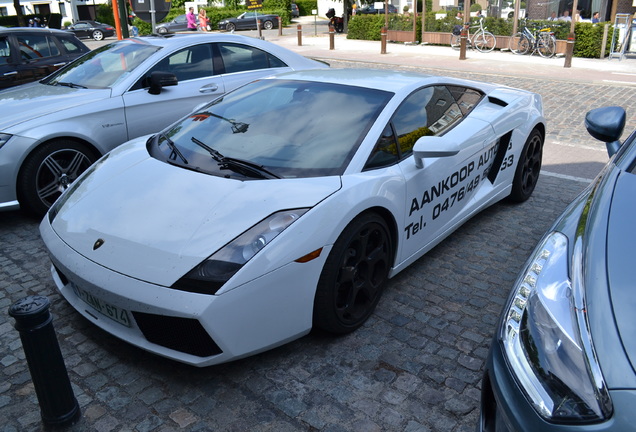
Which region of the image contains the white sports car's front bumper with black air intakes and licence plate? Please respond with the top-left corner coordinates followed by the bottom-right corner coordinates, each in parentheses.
top-left (40, 218), bottom-right (329, 366)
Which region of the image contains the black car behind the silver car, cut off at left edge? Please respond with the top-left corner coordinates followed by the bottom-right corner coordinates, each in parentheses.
top-left (0, 27), bottom-right (90, 89)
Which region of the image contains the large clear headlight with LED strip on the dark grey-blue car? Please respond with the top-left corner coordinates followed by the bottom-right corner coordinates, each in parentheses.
top-left (500, 232), bottom-right (611, 423)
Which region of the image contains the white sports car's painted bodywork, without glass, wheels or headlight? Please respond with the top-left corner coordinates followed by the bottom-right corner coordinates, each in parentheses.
top-left (41, 70), bottom-right (544, 366)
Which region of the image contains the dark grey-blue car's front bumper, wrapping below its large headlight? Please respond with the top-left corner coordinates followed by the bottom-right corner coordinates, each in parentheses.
top-left (477, 338), bottom-right (636, 432)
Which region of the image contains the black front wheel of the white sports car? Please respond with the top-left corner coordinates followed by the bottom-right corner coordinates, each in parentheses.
top-left (313, 213), bottom-right (393, 334)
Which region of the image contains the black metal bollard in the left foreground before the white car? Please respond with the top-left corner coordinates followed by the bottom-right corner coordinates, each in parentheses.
top-left (9, 296), bottom-right (81, 426)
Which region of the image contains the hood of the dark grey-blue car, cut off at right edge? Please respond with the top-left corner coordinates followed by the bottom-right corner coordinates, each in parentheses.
top-left (607, 172), bottom-right (636, 370)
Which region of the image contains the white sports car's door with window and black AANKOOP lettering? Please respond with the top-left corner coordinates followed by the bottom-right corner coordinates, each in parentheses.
top-left (392, 85), bottom-right (494, 257)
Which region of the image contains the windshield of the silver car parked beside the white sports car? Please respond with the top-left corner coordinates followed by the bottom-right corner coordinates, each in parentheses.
top-left (42, 40), bottom-right (160, 89)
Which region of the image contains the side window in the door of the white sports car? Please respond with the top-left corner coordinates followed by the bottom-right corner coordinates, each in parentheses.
top-left (393, 86), bottom-right (462, 157)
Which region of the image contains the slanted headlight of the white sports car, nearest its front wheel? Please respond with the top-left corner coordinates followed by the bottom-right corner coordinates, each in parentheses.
top-left (172, 208), bottom-right (309, 294)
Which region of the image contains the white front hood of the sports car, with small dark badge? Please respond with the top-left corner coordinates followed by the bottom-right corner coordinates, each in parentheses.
top-left (52, 140), bottom-right (341, 285)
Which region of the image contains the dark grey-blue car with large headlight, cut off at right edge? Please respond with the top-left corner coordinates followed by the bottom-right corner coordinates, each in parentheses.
top-left (477, 107), bottom-right (636, 432)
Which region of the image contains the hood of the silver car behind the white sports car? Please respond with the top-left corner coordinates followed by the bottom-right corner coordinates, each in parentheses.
top-left (0, 82), bottom-right (110, 133)
